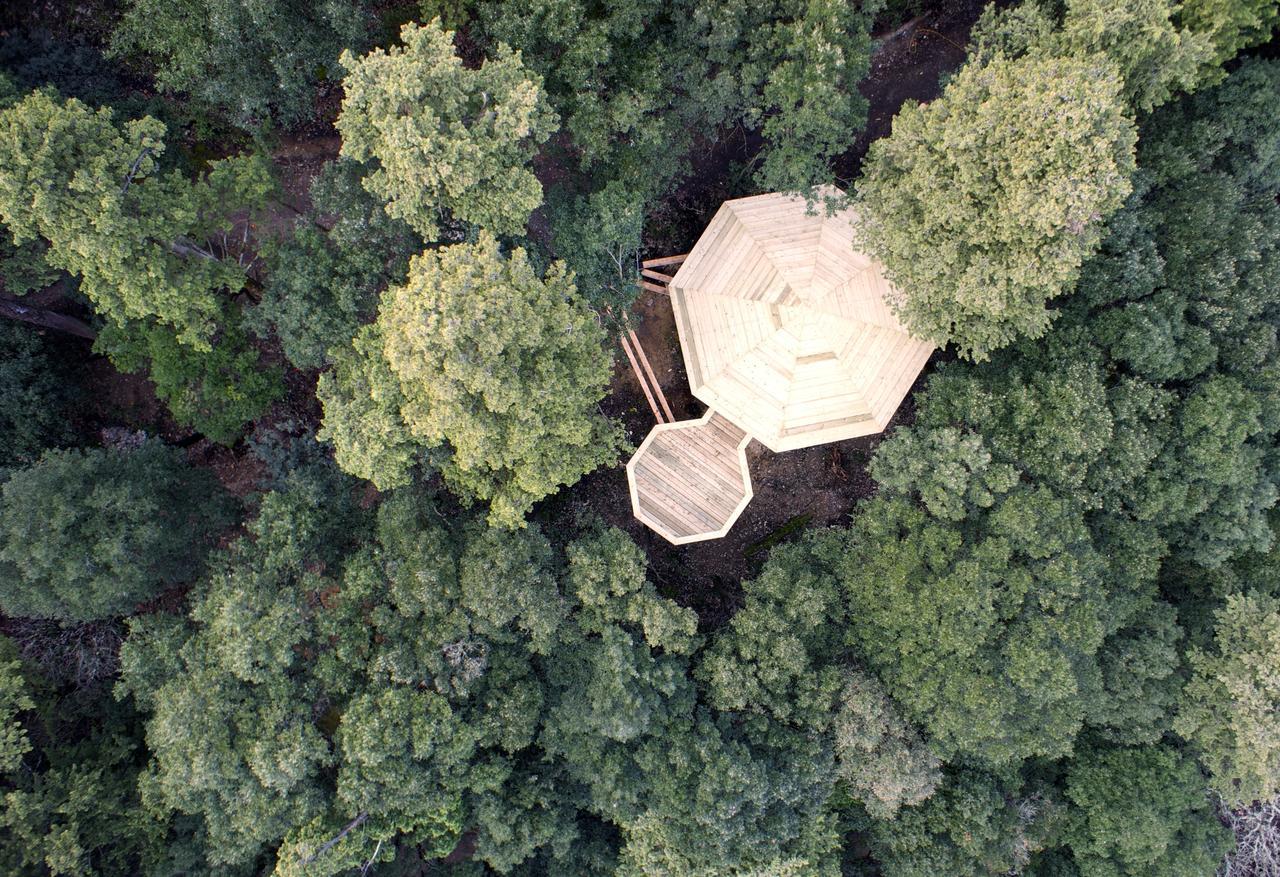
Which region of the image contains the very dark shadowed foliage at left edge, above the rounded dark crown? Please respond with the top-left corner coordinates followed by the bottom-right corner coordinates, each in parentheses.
top-left (0, 323), bottom-right (76, 466)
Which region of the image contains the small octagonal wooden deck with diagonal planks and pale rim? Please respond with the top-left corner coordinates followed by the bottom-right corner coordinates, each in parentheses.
top-left (627, 411), bottom-right (751, 545)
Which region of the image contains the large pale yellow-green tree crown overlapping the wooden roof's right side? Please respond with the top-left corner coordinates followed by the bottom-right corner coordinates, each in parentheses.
top-left (858, 54), bottom-right (1135, 361)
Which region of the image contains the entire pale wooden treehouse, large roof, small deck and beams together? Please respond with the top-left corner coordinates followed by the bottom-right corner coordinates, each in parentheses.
top-left (623, 188), bottom-right (933, 544)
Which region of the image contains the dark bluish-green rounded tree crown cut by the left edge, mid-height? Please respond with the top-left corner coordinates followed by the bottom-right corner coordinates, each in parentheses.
top-left (0, 440), bottom-right (235, 621)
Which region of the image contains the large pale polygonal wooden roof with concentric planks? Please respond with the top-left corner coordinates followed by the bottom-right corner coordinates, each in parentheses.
top-left (668, 187), bottom-right (933, 451)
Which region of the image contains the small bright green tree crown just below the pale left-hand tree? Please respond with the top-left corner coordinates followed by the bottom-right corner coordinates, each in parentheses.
top-left (95, 311), bottom-right (284, 444)
